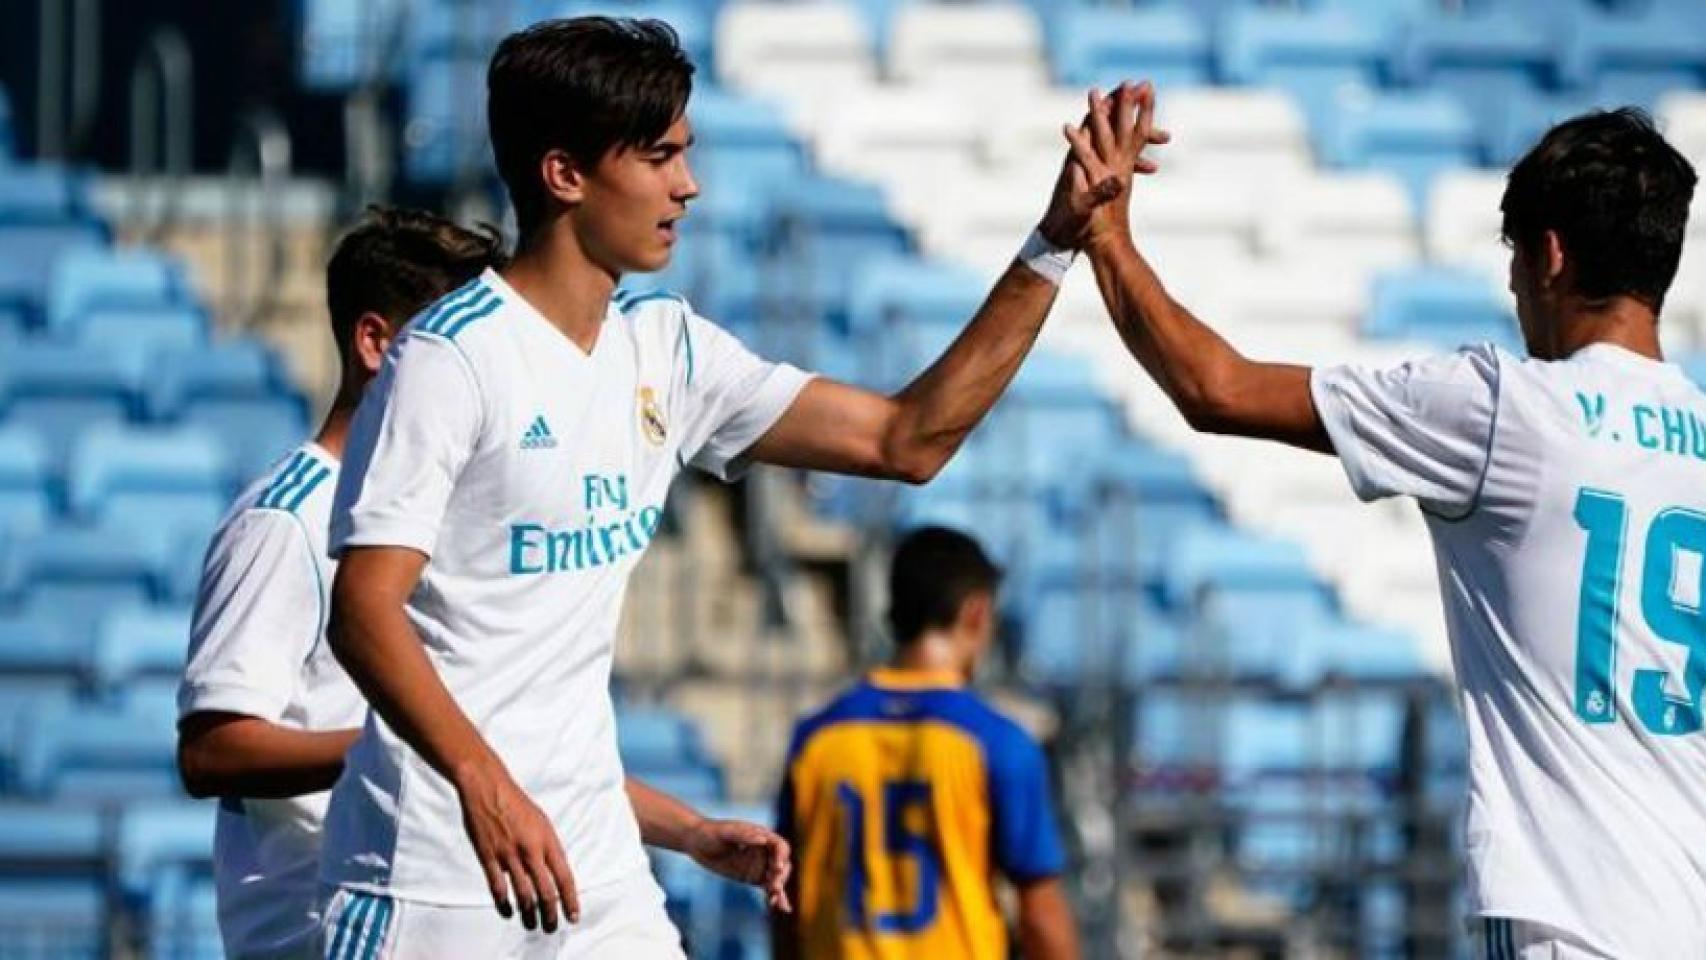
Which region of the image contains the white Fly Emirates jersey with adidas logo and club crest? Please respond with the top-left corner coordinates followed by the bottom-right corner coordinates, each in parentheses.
top-left (322, 271), bottom-right (807, 905)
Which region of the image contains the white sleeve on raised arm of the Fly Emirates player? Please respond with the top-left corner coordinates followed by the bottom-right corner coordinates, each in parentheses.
top-left (677, 310), bottom-right (810, 481)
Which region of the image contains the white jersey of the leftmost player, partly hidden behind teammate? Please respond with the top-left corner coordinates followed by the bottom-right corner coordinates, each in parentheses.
top-left (177, 443), bottom-right (367, 957)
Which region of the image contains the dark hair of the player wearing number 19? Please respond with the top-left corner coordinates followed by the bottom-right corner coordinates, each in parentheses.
top-left (1500, 107), bottom-right (1696, 310)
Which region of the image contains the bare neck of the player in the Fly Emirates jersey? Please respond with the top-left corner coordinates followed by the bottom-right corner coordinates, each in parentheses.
top-left (503, 217), bottom-right (618, 353)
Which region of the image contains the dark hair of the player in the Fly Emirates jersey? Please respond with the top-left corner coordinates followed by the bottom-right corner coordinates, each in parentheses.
top-left (486, 17), bottom-right (693, 237)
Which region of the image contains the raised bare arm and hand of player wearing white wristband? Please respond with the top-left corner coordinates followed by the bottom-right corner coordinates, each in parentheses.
top-left (749, 91), bottom-right (1167, 483)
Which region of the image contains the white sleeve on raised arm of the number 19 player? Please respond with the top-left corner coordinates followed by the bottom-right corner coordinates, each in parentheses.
top-left (1310, 344), bottom-right (1500, 518)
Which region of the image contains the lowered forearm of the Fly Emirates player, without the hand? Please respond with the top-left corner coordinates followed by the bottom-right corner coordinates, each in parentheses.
top-left (328, 593), bottom-right (502, 783)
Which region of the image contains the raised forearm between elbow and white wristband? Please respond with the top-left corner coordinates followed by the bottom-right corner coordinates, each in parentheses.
top-left (884, 261), bottom-right (1059, 479)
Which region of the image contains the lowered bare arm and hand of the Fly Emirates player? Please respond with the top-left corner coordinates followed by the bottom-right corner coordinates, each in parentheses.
top-left (326, 547), bottom-right (580, 931)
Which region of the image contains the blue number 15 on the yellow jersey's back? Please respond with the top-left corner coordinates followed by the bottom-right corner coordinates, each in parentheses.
top-left (836, 779), bottom-right (942, 934)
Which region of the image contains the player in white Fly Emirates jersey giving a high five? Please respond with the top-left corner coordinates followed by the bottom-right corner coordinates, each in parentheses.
top-left (322, 17), bottom-right (1160, 958)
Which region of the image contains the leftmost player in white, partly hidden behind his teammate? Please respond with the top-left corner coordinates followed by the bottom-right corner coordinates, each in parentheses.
top-left (177, 208), bottom-right (500, 958)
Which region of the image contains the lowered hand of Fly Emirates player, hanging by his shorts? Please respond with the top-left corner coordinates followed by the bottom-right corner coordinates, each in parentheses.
top-left (457, 760), bottom-right (580, 933)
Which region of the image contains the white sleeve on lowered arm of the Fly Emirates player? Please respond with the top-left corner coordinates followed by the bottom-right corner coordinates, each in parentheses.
top-left (331, 334), bottom-right (483, 556)
